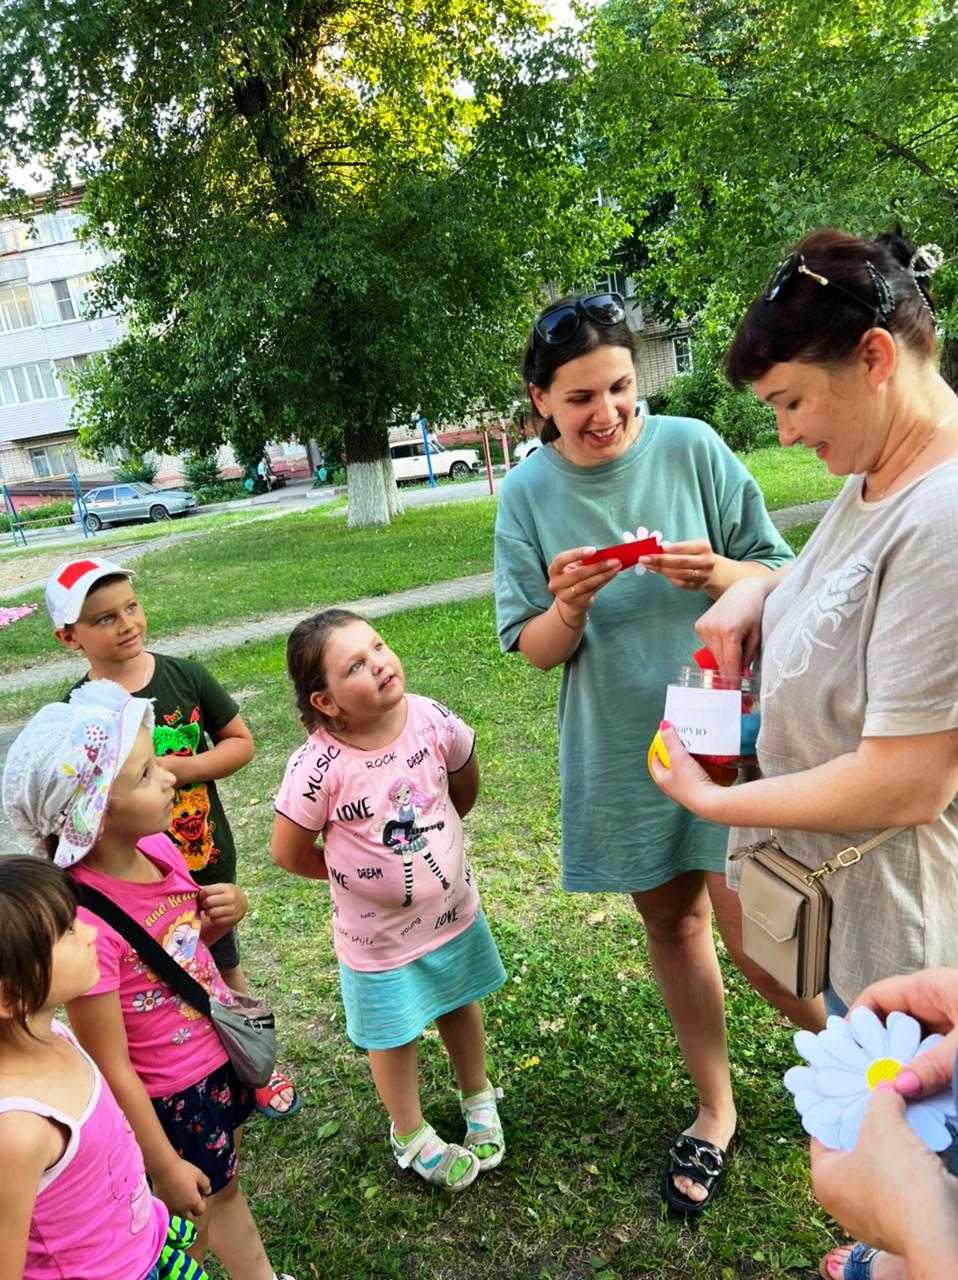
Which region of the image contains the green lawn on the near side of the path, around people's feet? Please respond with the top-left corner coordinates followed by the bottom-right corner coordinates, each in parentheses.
top-left (178, 602), bottom-right (830, 1280)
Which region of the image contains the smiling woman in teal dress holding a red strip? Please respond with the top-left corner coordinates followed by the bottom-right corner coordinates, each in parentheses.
top-left (496, 294), bottom-right (792, 1216)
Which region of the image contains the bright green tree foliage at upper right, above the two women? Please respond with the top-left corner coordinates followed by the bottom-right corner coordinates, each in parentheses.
top-left (588, 0), bottom-right (958, 355)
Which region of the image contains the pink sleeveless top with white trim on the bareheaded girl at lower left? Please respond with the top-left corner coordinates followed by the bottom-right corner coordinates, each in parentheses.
top-left (0, 1021), bottom-right (169, 1280)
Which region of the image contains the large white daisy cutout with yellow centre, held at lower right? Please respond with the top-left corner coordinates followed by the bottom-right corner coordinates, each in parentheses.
top-left (785, 1009), bottom-right (955, 1151)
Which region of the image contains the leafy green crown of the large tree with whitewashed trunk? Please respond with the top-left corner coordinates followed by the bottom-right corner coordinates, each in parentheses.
top-left (0, 0), bottom-right (625, 512)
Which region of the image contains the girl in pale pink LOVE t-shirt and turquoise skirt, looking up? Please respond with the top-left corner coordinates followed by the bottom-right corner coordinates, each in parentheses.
top-left (273, 609), bottom-right (506, 1190)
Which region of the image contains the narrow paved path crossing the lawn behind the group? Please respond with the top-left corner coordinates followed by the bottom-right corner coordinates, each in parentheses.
top-left (3, 502), bottom-right (829, 692)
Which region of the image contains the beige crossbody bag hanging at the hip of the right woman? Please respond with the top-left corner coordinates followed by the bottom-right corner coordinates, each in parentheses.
top-left (729, 827), bottom-right (905, 997)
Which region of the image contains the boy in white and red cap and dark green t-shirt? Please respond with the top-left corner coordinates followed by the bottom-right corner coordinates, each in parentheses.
top-left (45, 556), bottom-right (298, 1116)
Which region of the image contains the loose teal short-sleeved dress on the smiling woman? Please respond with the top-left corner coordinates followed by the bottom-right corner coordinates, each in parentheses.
top-left (496, 416), bottom-right (792, 893)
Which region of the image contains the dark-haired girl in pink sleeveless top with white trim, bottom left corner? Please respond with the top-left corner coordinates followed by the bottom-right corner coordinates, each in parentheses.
top-left (0, 858), bottom-right (199, 1280)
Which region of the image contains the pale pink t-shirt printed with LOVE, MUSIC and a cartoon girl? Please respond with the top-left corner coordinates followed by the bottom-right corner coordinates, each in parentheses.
top-left (275, 694), bottom-right (479, 973)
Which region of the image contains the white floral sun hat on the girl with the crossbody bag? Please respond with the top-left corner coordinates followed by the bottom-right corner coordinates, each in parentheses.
top-left (3, 680), bottom-right (154, 867)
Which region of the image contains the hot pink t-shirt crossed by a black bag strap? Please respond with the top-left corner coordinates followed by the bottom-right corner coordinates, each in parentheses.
top-left (69, 835), bottom-right (232, 1098)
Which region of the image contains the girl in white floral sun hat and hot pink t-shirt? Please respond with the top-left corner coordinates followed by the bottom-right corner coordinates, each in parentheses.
top-left (0, 680), bottom-right (289, 1280)
